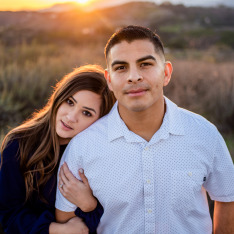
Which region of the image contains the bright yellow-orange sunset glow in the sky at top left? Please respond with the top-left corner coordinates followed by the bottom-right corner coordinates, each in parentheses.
top-left (0, 0), bottom-right (94, 11)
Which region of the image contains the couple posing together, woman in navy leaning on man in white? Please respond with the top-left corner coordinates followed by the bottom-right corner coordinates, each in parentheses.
top-left (0, 26), bottom-right (234, 234)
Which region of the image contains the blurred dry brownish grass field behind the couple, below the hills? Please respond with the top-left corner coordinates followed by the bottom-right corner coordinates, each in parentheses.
top-left (0, 43), bottom-right (234, 157)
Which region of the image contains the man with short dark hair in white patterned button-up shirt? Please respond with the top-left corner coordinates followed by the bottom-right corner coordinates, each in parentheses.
top-left (56, 26), bottom-right (234, 234)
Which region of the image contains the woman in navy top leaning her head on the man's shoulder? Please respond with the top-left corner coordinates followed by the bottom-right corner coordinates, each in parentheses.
top-left (0, 65), bottom-right (114, 233)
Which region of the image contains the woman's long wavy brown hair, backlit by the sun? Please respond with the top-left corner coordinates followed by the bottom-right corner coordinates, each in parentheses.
top-left (1, 65), bottom-right (115, 200)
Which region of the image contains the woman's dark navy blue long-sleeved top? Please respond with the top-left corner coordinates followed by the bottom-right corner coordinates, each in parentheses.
top-left (0, 140), bottom-right (103, 234)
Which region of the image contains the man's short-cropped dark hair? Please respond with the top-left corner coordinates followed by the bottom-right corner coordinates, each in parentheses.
top-left (104, 25), bottom-right (164, 59)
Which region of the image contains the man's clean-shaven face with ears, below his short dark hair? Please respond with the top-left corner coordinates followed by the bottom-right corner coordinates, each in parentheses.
top-left (105, 40), bottom-right (172, 112)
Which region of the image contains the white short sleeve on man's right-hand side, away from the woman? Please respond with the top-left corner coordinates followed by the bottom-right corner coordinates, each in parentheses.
top-left (204, 131), bottom-right (234, 202)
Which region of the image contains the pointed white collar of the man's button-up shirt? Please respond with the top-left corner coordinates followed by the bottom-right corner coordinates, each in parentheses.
top-left (108, 97), bottom-right (184, 142)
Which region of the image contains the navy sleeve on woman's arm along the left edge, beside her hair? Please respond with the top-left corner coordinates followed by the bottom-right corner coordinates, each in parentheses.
top-left (0, 140), bottom-right (55, 234)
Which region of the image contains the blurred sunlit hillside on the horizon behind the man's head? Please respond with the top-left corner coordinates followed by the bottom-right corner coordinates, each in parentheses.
top-left (0, 2), bottom-right (234, 49)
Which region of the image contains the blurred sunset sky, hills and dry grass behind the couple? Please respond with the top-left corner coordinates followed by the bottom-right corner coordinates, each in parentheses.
top-left (0, 0), bottom-right (234, 232)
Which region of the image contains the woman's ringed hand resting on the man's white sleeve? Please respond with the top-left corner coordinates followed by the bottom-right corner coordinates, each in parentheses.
top-left (58, 163), bottom-right (97, 212)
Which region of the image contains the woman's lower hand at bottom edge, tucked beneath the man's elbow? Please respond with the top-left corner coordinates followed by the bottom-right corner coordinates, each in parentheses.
top-left (49, 217), bottom-right (89, 234)
